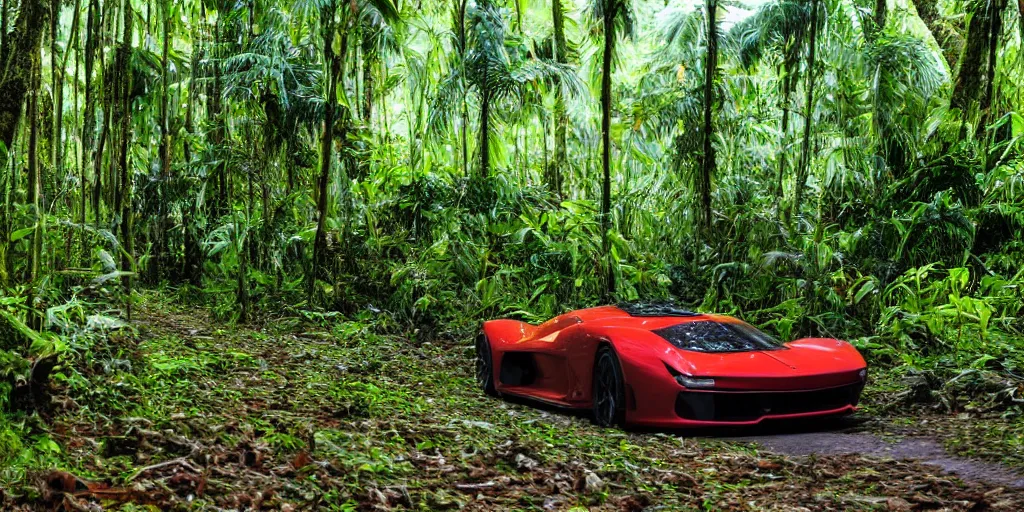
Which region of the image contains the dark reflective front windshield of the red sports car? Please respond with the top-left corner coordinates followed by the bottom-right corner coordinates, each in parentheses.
top-left (654, 321), bottom-right (784, 352)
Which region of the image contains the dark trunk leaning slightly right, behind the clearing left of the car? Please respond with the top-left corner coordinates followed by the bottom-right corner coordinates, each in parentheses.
top-left (308, 1), bottom-right (347, 302)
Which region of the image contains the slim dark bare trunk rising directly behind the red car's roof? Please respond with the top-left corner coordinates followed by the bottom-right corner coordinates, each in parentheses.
top-left (601, 12), bottom-right (615, 298)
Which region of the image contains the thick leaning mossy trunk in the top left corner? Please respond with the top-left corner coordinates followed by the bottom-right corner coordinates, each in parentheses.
top-left (0, 0), bottom-right (50, 149)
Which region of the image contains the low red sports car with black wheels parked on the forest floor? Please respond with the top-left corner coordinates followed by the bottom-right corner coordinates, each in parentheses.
top-left (476, 304), bottom-right (867, 428)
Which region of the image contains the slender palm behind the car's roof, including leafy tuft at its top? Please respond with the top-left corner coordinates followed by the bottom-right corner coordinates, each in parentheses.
top-left (590, 0), bottom-right (634, 297)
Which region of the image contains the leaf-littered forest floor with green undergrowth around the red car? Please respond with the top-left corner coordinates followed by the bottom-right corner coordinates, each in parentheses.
top-left (6, 295), bottom-right (1024, 511)
